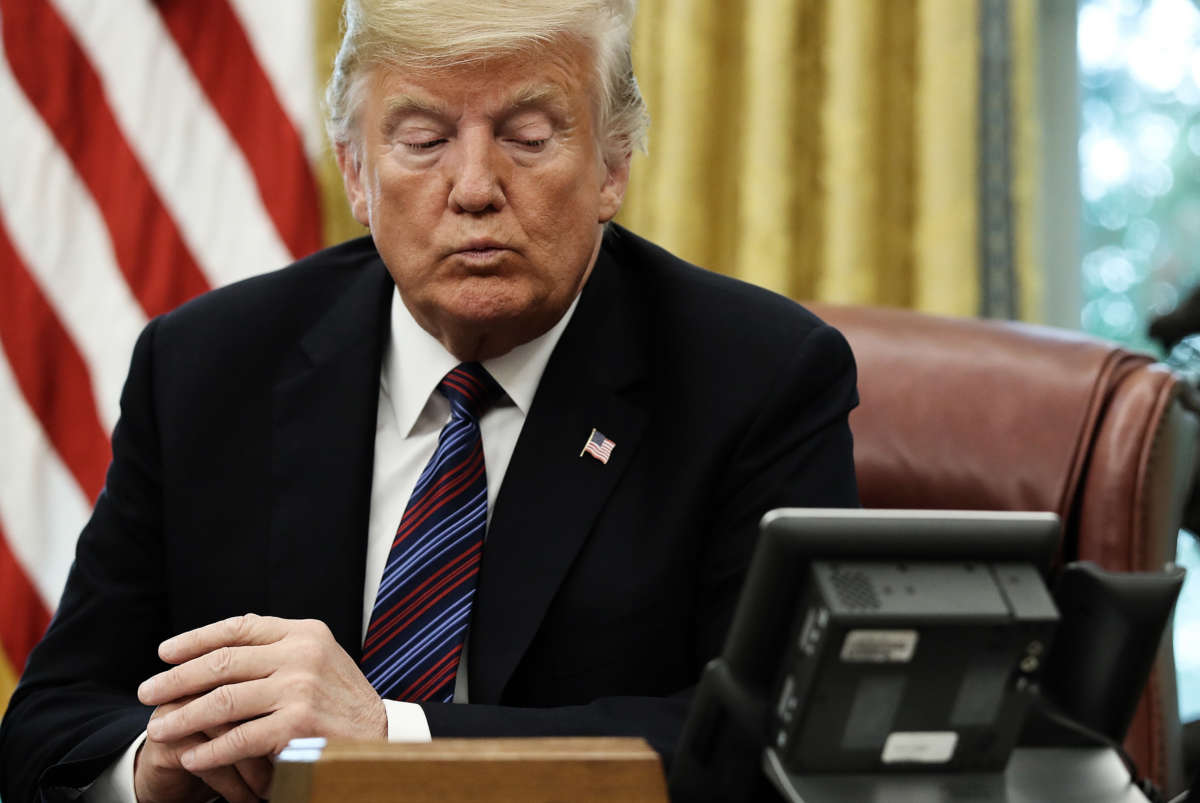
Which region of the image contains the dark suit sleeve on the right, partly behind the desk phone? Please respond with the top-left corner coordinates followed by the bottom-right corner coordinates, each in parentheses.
top-left (421, 325), bottom-right (858, 768)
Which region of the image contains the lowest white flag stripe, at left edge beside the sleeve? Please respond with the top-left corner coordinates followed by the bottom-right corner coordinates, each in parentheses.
top-left (0, 354), bottom-right (91, 611)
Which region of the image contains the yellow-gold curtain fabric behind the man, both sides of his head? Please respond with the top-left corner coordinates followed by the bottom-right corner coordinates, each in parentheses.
top-left (317, 0), bottom-right (1039, 314)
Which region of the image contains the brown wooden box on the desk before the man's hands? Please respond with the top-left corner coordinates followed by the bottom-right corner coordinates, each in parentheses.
top-left (271, 738), bottom-right (667, 803)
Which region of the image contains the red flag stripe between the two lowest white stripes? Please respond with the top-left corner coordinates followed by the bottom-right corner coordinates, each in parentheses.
top-left (0, 214), bottom-right (109, 501)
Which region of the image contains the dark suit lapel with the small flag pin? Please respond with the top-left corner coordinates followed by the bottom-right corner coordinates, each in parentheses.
top-left (468, 244), bottom-right (646, 703)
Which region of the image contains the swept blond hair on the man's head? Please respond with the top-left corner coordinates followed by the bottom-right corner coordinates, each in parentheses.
top-left (325, 0), bottom-right (649, 164)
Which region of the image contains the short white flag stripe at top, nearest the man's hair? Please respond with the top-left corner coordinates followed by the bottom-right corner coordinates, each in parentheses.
top-left (229, 0), bottom-right (325, 161)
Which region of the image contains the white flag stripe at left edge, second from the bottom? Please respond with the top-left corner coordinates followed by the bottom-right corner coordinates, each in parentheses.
top-left (0, 42), bottom-right (145, 432)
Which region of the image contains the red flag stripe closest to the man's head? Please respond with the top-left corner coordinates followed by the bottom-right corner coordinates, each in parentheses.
top-left (156, 0), bottom-right (322, 258)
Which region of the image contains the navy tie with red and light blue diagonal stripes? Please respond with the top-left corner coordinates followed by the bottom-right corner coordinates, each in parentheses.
top-left (361, 362), bottom-right (502, 702)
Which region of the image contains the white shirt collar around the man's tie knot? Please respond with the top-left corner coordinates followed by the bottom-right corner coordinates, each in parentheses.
top-left (379, 288), bottom-right (580, 438)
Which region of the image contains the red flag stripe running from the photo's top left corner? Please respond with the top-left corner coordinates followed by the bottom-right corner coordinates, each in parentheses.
top-left (0, 0), bottom-right (209, 317)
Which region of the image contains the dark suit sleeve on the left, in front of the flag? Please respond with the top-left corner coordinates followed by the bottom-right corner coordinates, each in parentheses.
top-left (0, 323), bottom-right (166, 801)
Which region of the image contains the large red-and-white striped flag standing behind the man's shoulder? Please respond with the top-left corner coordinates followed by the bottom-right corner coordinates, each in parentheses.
top-left (0, 0), bottom-right (343, 712)
